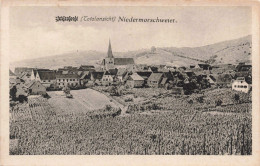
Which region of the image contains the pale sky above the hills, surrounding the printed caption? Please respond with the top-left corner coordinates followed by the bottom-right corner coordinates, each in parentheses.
top-left (9, 6), bottom-right (252, 62)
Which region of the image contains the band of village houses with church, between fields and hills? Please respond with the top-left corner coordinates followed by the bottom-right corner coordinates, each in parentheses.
top-left (9, 41), bottom-right (252, 99)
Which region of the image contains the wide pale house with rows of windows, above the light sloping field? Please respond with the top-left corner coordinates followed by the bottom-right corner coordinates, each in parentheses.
top-left (56, 74), bottom-right (80, 88)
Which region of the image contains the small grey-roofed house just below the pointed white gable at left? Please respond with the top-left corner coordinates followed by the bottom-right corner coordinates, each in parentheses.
top-left (26, 80), bottom-right (46, 95)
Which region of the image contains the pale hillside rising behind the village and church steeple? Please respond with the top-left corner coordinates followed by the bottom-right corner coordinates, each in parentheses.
top-left (10, 35), bottom-right (252, 68)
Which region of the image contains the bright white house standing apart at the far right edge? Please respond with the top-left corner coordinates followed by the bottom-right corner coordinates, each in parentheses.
top-left (232, 77), bottom-right (251, 93)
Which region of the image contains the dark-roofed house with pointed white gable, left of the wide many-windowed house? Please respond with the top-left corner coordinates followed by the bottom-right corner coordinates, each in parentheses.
top-left (34, 70), bottom-right (56, 88)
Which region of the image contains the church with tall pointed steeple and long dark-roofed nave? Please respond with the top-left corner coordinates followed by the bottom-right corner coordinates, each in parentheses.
top-left (101, 40), bottom-right (136, 71)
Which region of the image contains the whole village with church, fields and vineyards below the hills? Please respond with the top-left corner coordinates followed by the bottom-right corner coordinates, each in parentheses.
top-left (9, 41), bottom-right (252, 155)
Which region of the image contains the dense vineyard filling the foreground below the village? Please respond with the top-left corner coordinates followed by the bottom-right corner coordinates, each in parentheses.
top-left (10, 90), bottom-right (252, 155)
